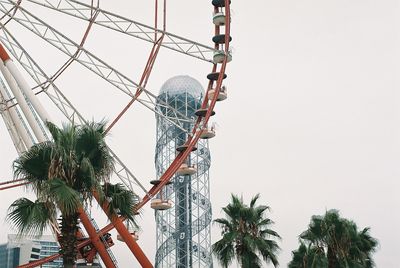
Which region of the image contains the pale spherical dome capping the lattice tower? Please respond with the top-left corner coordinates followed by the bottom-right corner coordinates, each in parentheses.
top-left (159, 75), bottom-right (204, 99)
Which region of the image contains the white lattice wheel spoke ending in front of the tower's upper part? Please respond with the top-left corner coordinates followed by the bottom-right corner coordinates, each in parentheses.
top-left (0, 0), bottom-right (194, 132)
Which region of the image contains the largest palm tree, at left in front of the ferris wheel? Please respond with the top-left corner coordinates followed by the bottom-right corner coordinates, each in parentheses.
top-left (7, 122), bottom-right (136, 267)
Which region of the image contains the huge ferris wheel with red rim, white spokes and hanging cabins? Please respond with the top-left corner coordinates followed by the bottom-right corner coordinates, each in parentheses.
top-left (0, 0), bottom-right (232, 268)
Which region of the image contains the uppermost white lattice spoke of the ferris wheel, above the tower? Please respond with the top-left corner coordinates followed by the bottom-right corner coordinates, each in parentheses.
top-left (26, 0), bottom-right (215, 62)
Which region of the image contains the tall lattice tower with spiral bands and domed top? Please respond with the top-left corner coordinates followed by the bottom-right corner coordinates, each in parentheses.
top-left (155, 76), bottom-right (212, 268)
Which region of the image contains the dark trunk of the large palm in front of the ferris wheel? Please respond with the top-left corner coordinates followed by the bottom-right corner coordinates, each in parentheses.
top-left (59, 214), bottom-right (78, 268)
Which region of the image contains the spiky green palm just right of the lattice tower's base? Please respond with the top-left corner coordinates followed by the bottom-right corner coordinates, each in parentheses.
top-left (212, 194), bottom-right (280, 268)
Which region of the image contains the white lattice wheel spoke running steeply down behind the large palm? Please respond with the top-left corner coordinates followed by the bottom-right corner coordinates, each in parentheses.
top-left (0, 24), bottom-right (147, 197)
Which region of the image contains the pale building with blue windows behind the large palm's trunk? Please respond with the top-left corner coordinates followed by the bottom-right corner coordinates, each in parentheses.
top-left (0, 234), bottom-right (62, 268)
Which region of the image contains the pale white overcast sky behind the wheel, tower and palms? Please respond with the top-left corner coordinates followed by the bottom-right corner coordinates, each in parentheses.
top-left (0, 0), bottom-right (400, 268)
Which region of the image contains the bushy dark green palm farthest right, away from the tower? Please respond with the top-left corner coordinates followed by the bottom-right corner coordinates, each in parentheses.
top-left (291, 210), bottom-right (378, 268)
